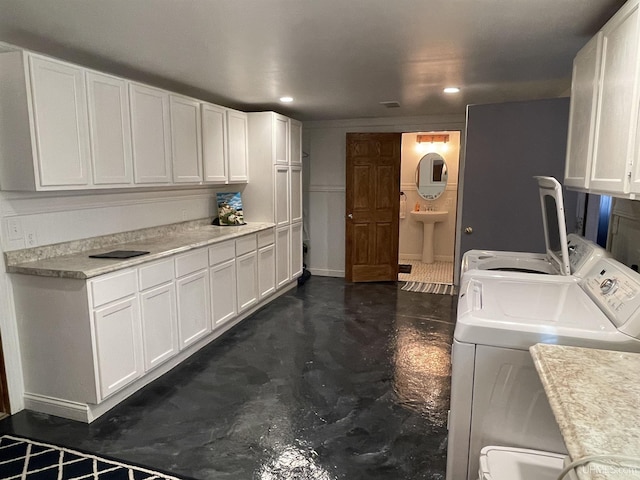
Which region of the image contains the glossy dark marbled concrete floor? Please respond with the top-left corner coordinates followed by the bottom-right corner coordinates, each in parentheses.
top-left (0, 277), bottom-right (456, 480)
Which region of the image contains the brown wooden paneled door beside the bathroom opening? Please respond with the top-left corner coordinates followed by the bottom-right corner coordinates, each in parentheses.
top-left (345, 133), bottom-right (402, 282)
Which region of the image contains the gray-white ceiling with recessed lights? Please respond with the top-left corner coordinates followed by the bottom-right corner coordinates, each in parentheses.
top-left (0, 0), bottom-right (624, 121)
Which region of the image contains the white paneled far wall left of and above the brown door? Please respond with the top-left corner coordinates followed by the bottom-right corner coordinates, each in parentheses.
top-left (303, 115), bottom-right (465, 277)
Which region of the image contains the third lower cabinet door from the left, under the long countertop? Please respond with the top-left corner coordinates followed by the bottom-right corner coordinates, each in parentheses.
top-left (176, 270), bottom-right (211, 349)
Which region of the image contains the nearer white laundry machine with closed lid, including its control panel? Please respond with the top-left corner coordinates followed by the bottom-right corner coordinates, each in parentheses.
top-left (446, 258), bottom-right (640, 480)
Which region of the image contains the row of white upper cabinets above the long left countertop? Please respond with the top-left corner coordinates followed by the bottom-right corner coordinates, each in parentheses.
top-left (0, 51), bottom-right (249, 190)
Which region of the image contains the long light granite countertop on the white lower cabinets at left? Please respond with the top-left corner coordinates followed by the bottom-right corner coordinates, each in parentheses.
top-left (5, 219), bottom-right (274, 279)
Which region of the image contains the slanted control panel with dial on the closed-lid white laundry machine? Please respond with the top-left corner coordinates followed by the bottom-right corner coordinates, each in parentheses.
top-left (580, 258), bottom-right (640, 338)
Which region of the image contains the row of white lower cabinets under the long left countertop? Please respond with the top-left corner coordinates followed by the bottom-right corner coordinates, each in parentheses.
top-left (12, 225), bottom-right (290, 422)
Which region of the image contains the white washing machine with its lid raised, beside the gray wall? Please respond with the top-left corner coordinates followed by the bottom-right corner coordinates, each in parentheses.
top-left (460, 177), bottom-right (609, 291)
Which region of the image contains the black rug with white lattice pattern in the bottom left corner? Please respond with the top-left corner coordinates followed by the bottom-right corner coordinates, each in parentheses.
top-left (0, 435), bottom-right (185, 480)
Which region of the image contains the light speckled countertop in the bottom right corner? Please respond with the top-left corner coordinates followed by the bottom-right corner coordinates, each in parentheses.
top-left (530, 344), bottom-right (640, 480)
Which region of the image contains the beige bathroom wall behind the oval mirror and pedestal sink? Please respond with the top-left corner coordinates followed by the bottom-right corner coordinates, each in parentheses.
top-left (399, 131), bottom-right (460, 262)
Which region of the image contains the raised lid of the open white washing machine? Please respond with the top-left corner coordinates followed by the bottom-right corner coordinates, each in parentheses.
top-left (534, 176), bottom-right (571, 275)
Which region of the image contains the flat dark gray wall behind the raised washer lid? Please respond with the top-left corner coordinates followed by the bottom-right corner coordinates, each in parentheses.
top-left (460, 98), bottom-right (577, 253)
